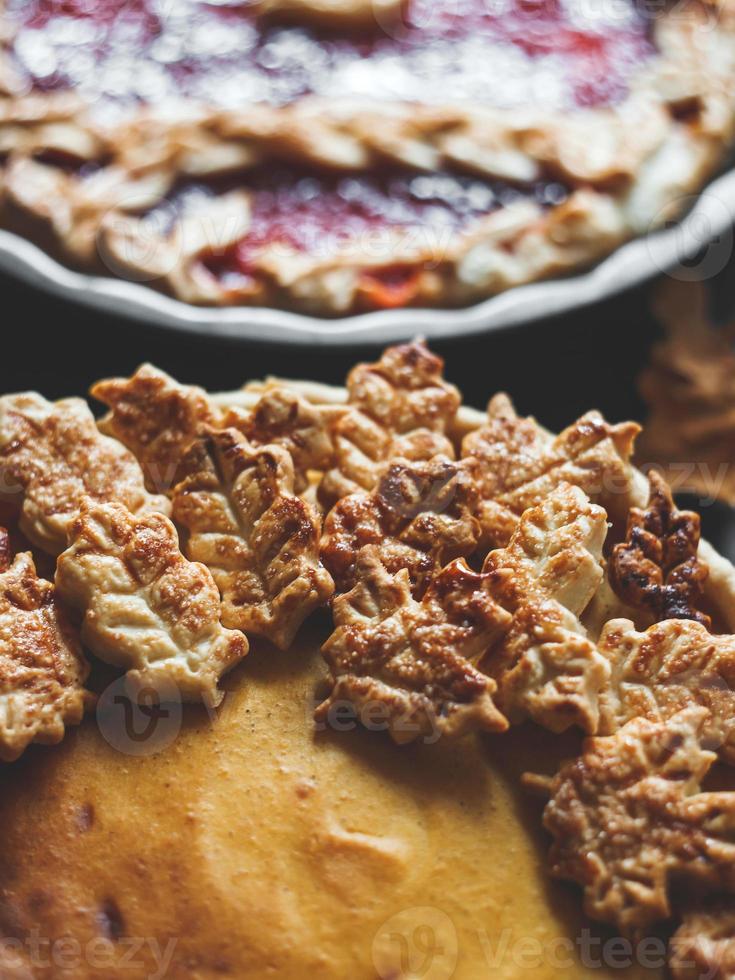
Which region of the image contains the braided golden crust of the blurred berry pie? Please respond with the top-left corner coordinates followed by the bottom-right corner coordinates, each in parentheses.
top-left (0, 0), bottom-right (735, 315)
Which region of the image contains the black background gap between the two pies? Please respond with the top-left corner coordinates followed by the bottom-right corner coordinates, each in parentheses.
top-left (0, 236), bottom-right (735, 440)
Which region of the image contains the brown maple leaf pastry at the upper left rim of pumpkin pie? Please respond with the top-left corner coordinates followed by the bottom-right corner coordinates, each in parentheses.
top-left (90, 364), bottom-right (219, 493)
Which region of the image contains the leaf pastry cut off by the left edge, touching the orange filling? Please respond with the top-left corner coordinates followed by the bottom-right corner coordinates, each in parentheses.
top-left (0, 528), bottom-right (92, 762)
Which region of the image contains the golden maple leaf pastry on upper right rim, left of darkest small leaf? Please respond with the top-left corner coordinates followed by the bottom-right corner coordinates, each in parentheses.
top-left (462, 394), bottom-right (640, 548)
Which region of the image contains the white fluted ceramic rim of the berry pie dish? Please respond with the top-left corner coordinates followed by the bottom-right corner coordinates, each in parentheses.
top-left (0, 170), bottom-right (735, 345)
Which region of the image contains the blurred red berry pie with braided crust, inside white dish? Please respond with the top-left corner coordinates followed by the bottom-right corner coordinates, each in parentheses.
top-left (0, 0), bottom-right (735, 316)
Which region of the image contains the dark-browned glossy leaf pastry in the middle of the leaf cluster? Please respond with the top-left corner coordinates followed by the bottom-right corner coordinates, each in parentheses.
top-left (322, 456), bottom-right (479, 597)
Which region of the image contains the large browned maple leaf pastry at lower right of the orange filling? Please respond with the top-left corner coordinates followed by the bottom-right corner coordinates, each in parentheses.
top-left (544, 707), bottom-right (735, 935)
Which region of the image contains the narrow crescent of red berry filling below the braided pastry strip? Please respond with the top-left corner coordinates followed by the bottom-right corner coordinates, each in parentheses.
top-left (164, 167), bottom-right (567, 307)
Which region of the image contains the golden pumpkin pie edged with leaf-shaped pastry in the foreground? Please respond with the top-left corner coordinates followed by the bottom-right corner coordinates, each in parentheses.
top-left (0, 343), bottom-right (735, 980)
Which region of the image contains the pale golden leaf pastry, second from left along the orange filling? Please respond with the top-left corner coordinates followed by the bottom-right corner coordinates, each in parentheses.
top-left (56, 502), bottom-right (248, 705)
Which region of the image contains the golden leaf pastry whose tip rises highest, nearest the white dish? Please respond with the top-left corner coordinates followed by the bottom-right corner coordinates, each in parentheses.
top-left (319, 342), bottom-right (460, 509)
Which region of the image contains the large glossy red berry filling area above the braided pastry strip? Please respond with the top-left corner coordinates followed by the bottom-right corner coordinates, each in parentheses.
top-left (7, 0), bottom-right (653, 108)
